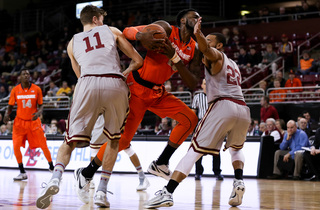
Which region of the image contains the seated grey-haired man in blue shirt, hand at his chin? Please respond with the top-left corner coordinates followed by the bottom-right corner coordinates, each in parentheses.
top-left (268, 120), bottom-right (310, 180)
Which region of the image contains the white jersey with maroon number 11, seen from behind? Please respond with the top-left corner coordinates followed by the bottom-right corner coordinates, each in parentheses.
top-left (73, 25), bottom-right (122, 76)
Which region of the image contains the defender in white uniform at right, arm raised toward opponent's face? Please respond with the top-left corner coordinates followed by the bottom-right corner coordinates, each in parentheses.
top-left (144, 18), bottom-right (250, 209)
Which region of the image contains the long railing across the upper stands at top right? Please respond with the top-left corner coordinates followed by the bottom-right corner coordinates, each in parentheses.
top-left (202, 11), bottom-right (320, 28)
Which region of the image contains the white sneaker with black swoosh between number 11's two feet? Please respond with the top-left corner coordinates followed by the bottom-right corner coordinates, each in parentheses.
top-left (74, 168), bottom-right (91, 204)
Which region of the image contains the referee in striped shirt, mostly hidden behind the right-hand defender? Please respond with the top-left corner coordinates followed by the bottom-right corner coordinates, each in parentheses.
top-left (191, 79), bottom-right (223, 180)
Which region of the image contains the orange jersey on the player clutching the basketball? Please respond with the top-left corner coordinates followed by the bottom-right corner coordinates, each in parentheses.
top-left (127, 26), bottom-right (196, 84)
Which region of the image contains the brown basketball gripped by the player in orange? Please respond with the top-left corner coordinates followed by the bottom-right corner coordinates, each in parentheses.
top-left (137, 30), bottom-right (165, 50)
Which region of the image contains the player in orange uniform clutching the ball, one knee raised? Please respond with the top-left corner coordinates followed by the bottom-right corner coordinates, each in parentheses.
top-left (74, 9), bottom-right (201, 194)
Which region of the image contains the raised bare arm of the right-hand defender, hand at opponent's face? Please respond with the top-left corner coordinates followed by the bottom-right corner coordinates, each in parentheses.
top-left (194, 17), bottom-right (223, 75)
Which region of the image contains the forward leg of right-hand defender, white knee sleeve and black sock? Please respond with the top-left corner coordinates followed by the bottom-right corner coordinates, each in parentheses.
top-left (144, 148), bottom-right (203, 208)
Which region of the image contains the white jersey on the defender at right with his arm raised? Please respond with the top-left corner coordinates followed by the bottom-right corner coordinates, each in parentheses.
top-left (205, 53), bottom-right (244, 102)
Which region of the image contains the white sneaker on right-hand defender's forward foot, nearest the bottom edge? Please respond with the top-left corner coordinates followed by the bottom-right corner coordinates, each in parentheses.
top-left (144, 187), bottom-right (173, 209)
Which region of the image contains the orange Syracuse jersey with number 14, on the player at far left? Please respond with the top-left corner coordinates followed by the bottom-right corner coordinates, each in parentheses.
top-left (9, 84), bottom-right (43, 120)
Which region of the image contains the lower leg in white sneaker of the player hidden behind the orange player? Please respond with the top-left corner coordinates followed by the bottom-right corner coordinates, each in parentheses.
top-left (124, 145), bottom-right (150, 191)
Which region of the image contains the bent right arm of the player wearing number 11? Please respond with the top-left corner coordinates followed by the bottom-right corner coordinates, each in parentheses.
top-left (110, 27), bottom-right (143, 76)
